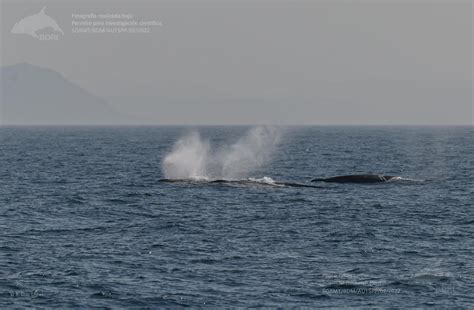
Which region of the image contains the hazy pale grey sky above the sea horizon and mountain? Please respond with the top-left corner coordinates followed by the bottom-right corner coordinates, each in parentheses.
top-left (0, 0), bottom-right (474, 124)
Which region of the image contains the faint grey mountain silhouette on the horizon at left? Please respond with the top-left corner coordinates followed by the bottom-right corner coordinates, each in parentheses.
top-left (0, 63), bottom-right (126, 125)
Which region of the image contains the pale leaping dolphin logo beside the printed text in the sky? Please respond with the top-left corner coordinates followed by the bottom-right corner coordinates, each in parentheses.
top-left (12, 7), bottom-right (64, 39)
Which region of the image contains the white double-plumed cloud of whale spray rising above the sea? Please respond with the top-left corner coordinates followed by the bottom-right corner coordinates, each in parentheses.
top-left (162, 126), bottom-right (281, 180)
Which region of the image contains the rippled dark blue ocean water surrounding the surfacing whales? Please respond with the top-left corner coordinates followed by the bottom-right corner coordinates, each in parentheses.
top-left (0, 127), bottom-right (474, 308)
